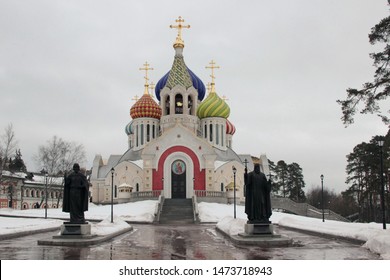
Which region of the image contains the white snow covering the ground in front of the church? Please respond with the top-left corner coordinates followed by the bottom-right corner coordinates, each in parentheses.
top-left (0, 200), bottom-right (390, 259)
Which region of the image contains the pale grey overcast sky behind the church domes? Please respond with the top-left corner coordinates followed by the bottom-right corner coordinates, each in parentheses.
top-left (0, 0), bottom-right (389, 192)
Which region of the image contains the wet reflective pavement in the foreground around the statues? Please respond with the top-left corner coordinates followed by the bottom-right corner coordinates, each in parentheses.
top-left (0, 225), bottom-right (380, 260)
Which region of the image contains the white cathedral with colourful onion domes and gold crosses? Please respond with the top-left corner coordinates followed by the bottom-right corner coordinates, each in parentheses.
top-left (90, 17), bottom-right (268, 203)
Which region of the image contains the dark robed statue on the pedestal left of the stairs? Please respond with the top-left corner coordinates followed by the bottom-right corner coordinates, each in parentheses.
top-left (62, 163), bottom-right (89, 224)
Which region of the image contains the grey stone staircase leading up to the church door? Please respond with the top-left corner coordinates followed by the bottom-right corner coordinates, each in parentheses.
top-left (159, 199), bottom-right (194, 225)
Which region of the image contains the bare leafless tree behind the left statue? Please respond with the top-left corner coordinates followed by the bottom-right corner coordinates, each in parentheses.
top-left (34, 136), bottom-right (86, 175)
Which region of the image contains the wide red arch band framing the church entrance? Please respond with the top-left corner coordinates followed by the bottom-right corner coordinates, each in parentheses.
top-left (153, 146), bottom-right (206, 190)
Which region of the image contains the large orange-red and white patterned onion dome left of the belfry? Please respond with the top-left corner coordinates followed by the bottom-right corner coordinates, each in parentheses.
top-left (130, 93), bottom-right (162, 119)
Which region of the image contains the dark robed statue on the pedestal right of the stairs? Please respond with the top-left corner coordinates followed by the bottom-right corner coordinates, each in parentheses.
top-left (244, 163), bottom-right (272, 224)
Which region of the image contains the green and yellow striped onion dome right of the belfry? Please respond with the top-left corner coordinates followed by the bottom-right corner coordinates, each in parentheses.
top-left (197, 92), bottom-right (230, 119)
